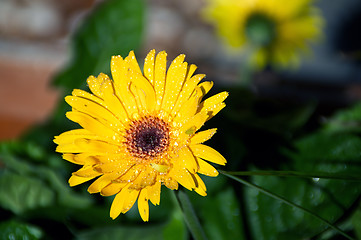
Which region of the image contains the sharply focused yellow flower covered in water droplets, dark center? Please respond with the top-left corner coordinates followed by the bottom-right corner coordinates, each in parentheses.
top-left (54, 50), bottom-right (228, 221)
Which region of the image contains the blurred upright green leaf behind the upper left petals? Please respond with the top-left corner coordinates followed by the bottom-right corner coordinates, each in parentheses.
top-left (55, 0), bottom-right (144, 91)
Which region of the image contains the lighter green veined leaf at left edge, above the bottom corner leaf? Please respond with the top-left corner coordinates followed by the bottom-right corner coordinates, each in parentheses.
top-left (0, 172), bottom-right (54, 214)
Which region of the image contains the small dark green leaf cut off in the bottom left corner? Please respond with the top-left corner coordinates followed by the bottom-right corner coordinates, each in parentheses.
top-left (0, 221), bottom-right (43, 240)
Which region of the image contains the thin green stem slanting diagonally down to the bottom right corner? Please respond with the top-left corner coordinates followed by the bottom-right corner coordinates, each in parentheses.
top-left (219, 171), bottom-right (354, 240)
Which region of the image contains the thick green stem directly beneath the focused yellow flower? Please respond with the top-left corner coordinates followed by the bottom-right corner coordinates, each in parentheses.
top-left (172, 190), bottom-right (207, 240)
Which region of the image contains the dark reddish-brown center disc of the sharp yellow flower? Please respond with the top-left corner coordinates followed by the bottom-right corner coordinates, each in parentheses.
top-left (126, 117), bottom-right (169, 159)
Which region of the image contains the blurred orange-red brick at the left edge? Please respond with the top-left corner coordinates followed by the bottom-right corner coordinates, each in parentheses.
top-left (0, 51), bottom-right (59, 140)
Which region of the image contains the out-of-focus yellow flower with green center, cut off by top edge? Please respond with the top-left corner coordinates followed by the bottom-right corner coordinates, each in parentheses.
top-left (204, 0), bottom-right (322, 67)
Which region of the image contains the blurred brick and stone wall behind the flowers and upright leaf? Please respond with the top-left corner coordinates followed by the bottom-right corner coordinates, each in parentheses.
top-left (0, 0), bottom-right (361, 139)
